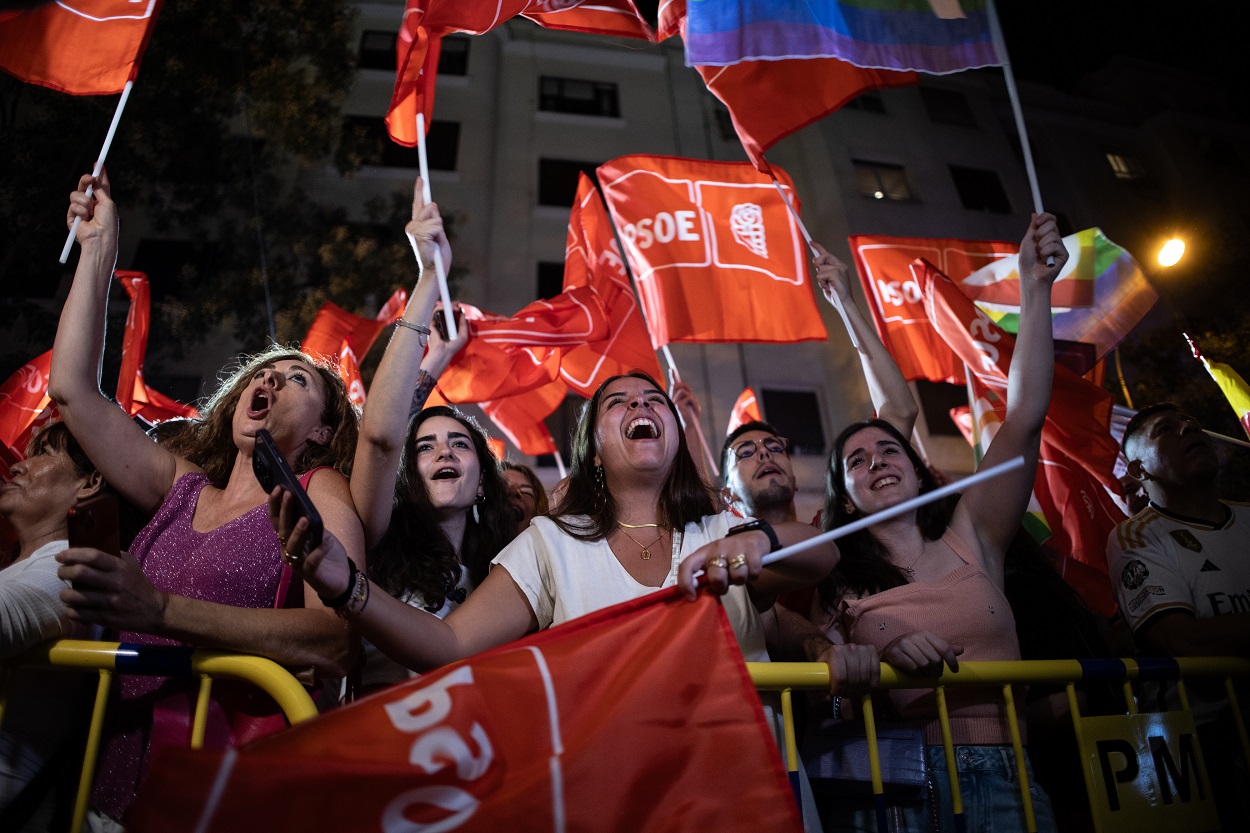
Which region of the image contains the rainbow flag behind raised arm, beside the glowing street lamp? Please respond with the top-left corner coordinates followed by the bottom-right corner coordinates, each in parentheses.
top-left (959, 228), bottom-right (1159, 359)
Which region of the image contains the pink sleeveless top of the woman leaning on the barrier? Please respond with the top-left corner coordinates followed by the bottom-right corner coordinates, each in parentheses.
top-left (839, 529), bottom-right (1024, 745)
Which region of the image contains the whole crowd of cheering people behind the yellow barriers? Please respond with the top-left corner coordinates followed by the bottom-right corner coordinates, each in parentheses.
top-left (0, 174), bottom-right (1250, 830)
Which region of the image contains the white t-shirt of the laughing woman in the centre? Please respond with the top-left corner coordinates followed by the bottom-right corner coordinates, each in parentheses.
top-left (491, 512), bottom-right (769, 662)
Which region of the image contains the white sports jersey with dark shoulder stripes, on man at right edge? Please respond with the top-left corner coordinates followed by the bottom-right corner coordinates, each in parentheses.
top-left (1106, 502), bottom-right (1250, 632)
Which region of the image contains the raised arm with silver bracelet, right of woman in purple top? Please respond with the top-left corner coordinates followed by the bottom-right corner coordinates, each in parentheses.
top-left (351, 179), bottom-right (468, 547)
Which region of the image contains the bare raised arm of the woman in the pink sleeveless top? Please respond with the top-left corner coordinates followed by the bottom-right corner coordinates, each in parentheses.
top-left (951, 214), bottom-right (1068, 575)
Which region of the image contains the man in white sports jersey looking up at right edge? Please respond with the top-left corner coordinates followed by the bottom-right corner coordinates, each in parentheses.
top-left (1106, 403), bottom-right (1250, 815)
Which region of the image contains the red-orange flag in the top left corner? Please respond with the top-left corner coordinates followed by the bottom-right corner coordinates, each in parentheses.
top-left (0, 0), bottom-right (161, 95)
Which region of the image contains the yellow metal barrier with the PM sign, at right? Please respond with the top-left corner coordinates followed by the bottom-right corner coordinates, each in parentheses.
top-left (746, 657), bottom-right (1250, 833)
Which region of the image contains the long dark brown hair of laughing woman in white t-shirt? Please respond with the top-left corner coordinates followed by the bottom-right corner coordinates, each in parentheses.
top-left (551, 370), bottom-right (716, 540)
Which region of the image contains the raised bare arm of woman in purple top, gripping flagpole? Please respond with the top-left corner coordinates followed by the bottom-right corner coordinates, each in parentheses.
top-left (48, 171), bottom-right (180, 512)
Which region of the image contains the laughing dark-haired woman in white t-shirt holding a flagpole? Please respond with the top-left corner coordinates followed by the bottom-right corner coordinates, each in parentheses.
top-left (270, 373), bottom-right (838, 670)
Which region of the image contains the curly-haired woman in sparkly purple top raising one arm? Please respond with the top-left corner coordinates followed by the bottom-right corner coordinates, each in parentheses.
top-left (49, 174), bottom-right (364, 822)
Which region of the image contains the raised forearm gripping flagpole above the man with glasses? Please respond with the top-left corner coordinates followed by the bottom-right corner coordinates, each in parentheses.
top-left (811, 241), bottom-right (920, 437)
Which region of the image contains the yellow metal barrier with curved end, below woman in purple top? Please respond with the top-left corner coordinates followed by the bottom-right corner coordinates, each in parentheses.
top-left (0, 639), bottom-right (318, 833)
